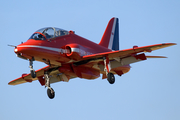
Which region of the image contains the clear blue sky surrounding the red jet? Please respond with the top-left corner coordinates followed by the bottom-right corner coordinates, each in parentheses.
top-left (0, 0), bottom-right (180, 120)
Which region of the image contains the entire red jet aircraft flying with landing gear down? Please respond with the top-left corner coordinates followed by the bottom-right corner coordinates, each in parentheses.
top-left (8, 18), bottom-right (176, 99)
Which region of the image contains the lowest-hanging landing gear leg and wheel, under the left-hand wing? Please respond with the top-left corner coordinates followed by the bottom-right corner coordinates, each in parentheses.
top-left (44, 72), bottom-right (55, 99)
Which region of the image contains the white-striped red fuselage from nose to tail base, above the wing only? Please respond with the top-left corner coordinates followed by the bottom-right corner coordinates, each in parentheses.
top-left (15, 31), bottom-right (111, 65)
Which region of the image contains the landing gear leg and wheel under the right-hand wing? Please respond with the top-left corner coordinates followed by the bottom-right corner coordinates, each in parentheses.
top-left (103, 57), bottom-right (115, 84)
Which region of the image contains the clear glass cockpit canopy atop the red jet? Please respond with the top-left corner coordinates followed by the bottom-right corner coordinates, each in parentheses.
top-left (29, 27), bottom-right (69, 40)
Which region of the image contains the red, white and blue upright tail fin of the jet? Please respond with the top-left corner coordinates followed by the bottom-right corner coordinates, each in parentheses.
top-left (99, 18), bottom-right (119, 50)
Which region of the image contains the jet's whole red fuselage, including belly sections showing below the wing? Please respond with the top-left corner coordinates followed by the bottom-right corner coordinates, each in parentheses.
top-left (15, 27), bottom-right (130, 79)
